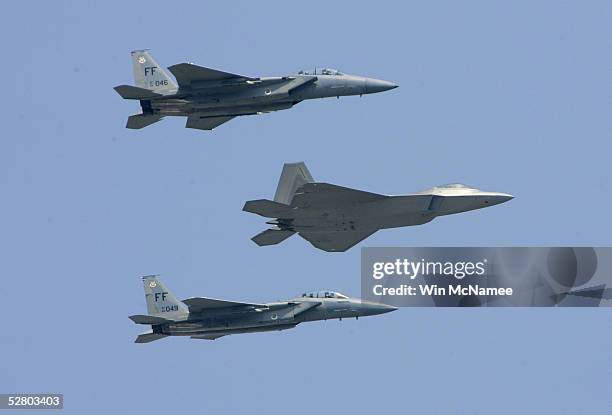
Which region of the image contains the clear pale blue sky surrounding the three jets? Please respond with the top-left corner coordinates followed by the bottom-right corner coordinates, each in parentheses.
top-left (0, 0), bottom-right (612, 415)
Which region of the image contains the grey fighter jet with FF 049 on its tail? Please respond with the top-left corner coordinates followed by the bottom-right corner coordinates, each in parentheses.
top-left (130, 275), bottom-right (396, 343)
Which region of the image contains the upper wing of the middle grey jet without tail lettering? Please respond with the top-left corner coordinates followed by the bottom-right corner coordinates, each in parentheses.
top-left (291, 183), bottom-right (387, 208)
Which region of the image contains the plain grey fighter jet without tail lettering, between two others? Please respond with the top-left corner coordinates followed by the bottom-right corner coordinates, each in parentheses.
top-left (243, 162), bottom-right (513, 252)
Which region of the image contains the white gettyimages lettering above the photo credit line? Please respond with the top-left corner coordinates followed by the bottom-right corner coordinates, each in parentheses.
top-left (372, 258), bottom-right (488, 280)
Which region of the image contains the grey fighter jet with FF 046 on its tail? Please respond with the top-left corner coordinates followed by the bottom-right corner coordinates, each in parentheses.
top-left (115, 50), bottom-right (397, 130)
